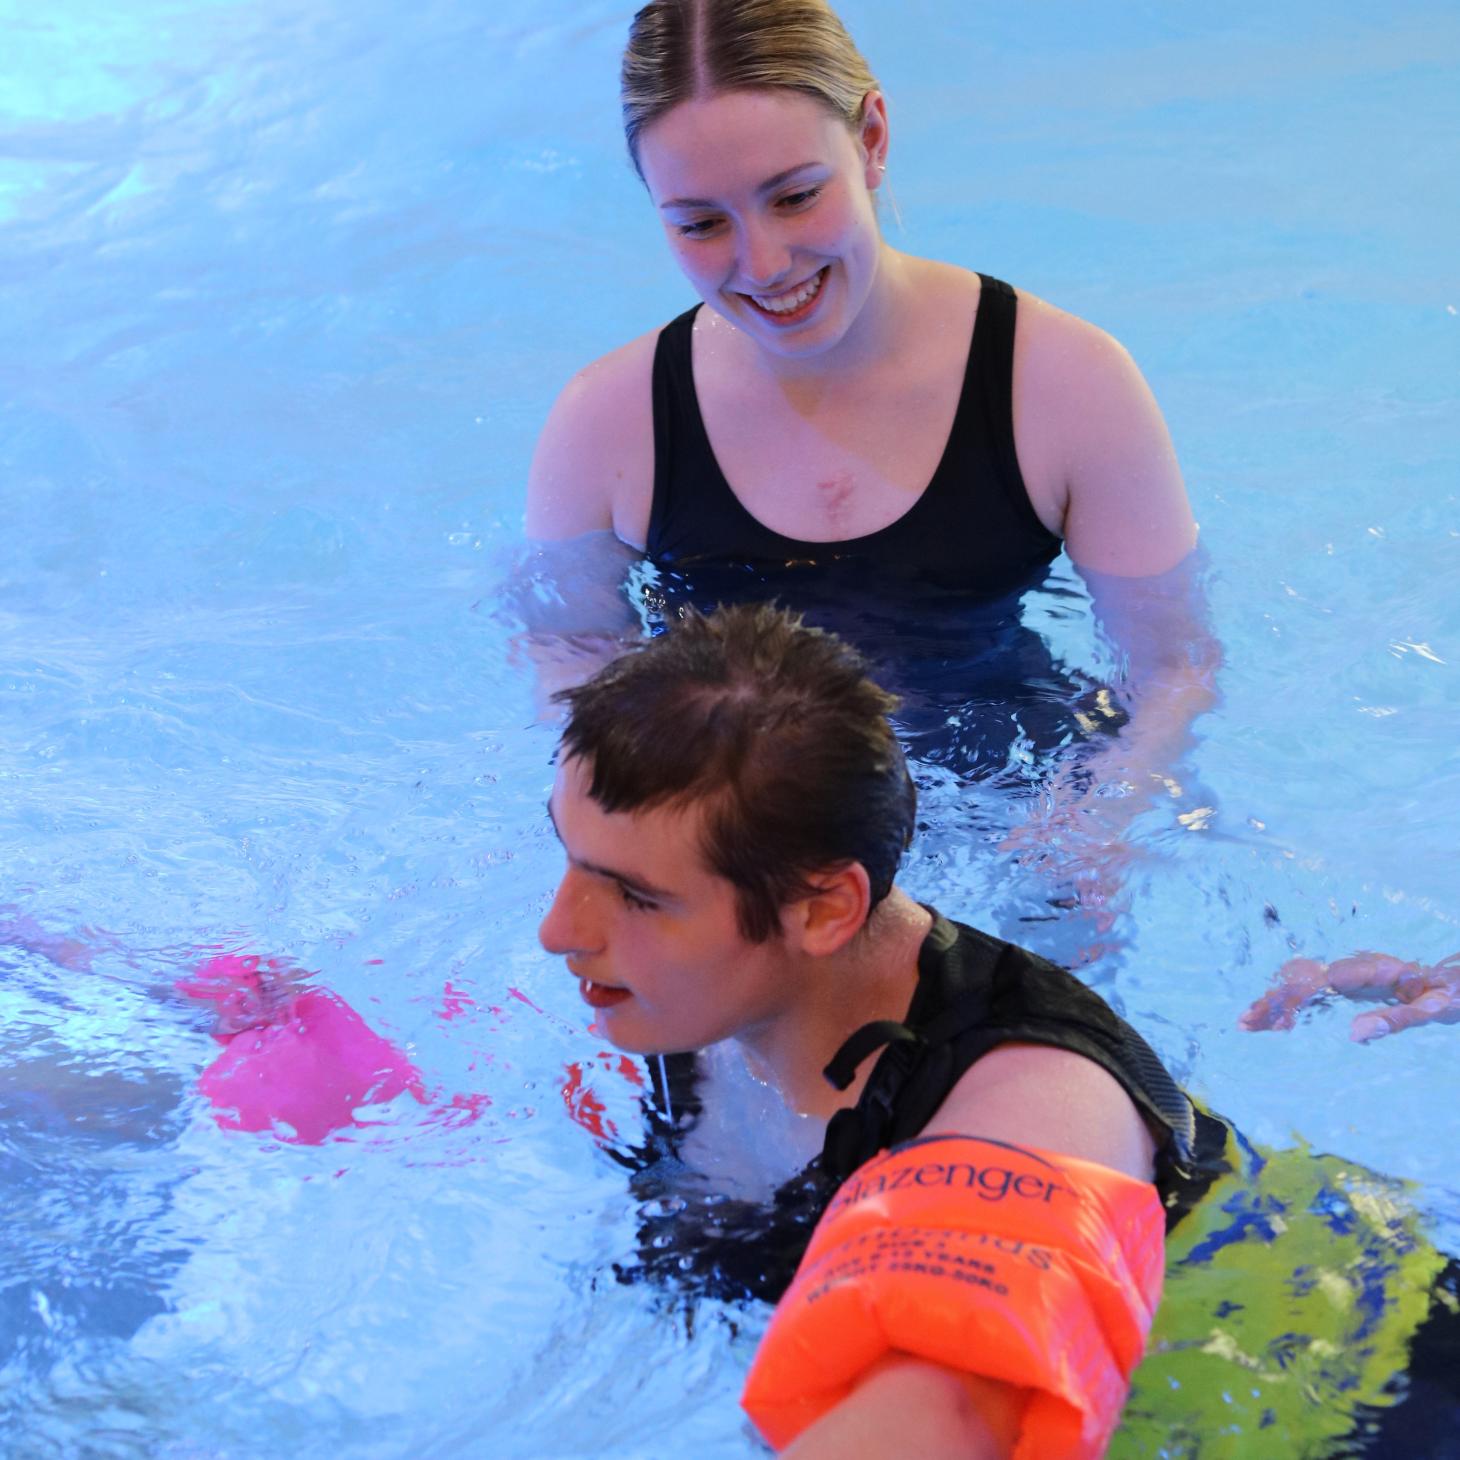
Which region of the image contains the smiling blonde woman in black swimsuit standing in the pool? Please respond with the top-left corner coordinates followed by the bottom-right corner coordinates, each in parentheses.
top-left (527, 0), bottom-right (1216, 876)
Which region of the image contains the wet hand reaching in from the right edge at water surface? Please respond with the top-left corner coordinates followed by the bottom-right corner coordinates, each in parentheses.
top-left (1238, 952), bottom-right (1460, 1044)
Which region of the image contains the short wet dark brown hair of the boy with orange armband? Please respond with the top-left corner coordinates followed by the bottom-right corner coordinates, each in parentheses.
top-left (555, 604), bottom-right (917, 943)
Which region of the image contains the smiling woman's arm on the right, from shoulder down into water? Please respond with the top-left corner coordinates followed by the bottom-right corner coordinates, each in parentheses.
top-left (1015, 298), bottom-right (1222, 899)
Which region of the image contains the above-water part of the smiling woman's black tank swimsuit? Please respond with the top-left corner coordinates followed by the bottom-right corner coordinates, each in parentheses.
top-left (647, 274), bottom-right (1060, 597)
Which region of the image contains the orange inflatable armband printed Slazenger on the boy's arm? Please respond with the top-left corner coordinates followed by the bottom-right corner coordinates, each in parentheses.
top-left (740, 1136), bottom-right (1165, 1460)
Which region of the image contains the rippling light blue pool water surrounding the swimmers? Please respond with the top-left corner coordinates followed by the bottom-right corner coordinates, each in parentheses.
top-left (0, 0), bottom-right (1460, 1460)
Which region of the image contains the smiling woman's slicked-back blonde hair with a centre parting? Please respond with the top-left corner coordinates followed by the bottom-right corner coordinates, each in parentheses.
top-left (619, 0), bottom-right (877, 177)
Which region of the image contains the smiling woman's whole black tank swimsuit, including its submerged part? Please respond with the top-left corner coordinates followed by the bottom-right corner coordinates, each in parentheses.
top-left (631, 274), bottom-right (1124, 780)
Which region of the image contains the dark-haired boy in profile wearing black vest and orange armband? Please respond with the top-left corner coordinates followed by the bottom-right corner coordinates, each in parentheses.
top-left (540, 607), bottom-right (1197, 1456)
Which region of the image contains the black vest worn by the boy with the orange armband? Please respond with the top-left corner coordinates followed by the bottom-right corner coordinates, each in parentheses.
top-left (618, 910), bottom-right (1228, 1302)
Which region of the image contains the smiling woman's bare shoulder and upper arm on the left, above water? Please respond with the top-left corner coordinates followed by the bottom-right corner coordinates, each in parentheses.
top-left (527, 330), bottom-right (660, 548)
